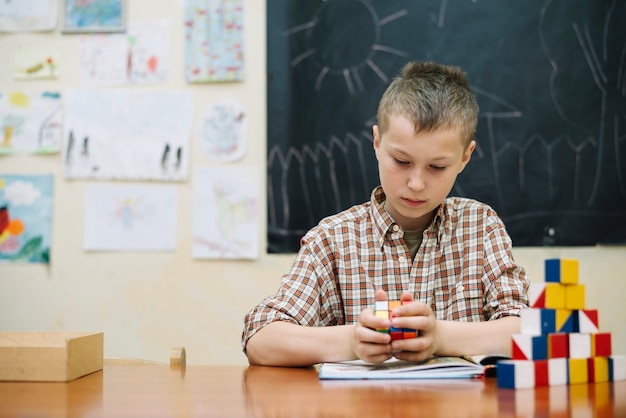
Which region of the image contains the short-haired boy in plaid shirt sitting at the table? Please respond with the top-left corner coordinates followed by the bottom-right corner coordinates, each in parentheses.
top-left (242, 62), bottom-right (529, 366)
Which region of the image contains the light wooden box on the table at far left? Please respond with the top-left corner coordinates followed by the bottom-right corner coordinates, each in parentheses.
top-left (0, 332), bottom-right (104, 382)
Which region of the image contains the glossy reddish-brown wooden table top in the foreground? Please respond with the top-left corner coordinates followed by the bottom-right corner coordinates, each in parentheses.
top-left (0, 365), bottom-right (626, 418)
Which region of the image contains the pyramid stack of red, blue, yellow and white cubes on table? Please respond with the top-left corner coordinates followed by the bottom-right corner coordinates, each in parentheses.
top-left (497, 259), bottom-right (626, 389)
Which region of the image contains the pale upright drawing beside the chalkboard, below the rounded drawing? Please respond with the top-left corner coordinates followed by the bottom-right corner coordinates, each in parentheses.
top-left (192, 166), bottom-right (259, 259)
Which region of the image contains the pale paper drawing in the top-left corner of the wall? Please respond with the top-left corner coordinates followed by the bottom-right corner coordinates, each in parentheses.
top-left (0, 0), bottom-right (59, 32)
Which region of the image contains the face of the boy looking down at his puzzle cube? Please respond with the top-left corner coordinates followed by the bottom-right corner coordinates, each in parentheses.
top-left (374, 116), bottom-right (476, 231)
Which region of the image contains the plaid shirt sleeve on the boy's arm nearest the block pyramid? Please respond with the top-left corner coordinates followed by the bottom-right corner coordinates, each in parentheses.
top-left (483, 210), bottom-right (529, 320)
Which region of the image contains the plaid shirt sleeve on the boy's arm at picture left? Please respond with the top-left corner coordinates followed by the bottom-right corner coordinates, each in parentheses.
top-left (241, 231), bottom-right (343, 352)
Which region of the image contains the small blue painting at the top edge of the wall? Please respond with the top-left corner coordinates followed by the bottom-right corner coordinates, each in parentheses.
top-left (63, 0), bottom-right (126, 32)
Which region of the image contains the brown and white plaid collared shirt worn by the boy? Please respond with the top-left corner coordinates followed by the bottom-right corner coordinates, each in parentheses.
top-left (242, 186), bottom-right (529, 350)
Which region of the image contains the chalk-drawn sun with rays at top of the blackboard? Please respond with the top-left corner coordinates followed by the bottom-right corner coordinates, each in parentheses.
top-left (285, 0), bottom-right (408, 95)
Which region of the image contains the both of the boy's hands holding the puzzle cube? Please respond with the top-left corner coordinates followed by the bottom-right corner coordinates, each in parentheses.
top-left (353, 289), bottom-right (438, 363)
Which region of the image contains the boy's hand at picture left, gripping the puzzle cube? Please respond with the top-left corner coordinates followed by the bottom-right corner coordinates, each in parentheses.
top-left (352, 289), bottom-right (392, 363)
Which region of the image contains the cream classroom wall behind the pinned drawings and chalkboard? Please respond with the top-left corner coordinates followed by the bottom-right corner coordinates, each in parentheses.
top-left (0, 0), bottom-right (626, 364)
